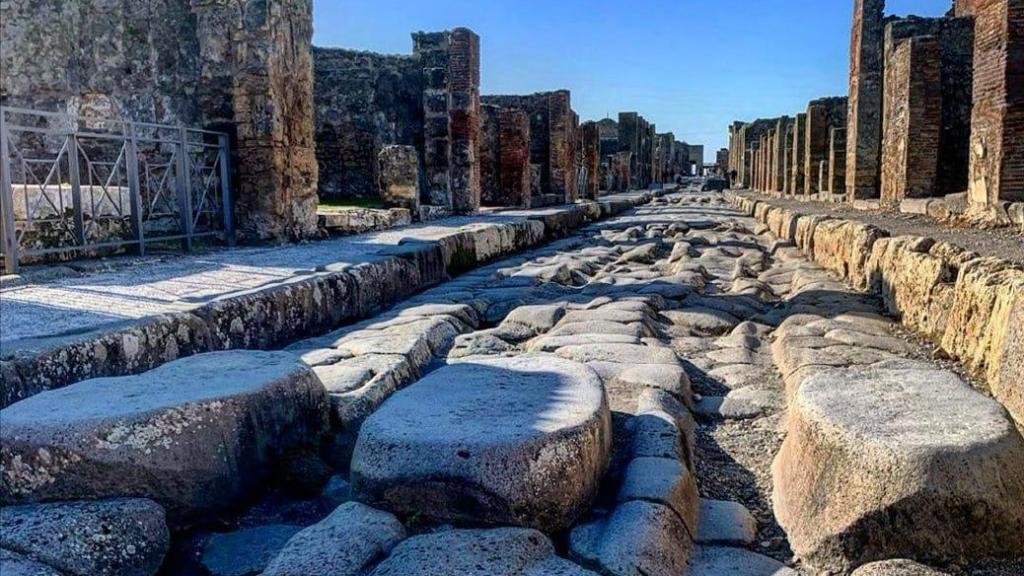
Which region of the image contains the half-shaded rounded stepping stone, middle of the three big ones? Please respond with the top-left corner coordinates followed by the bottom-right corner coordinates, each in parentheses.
top-left (351, 355), bottom-right (611, 532)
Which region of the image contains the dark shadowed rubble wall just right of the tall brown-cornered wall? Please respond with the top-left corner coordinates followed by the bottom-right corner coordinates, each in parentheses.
top-left (313, 48), bottom-right (424, 198)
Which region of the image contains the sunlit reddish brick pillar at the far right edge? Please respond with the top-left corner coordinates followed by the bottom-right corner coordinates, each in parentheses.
top-left (969, 0), bottom-right (1024, 208)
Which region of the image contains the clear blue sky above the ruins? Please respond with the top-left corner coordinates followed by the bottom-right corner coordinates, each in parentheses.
top-left (313, 0), bottom-right (950, 160)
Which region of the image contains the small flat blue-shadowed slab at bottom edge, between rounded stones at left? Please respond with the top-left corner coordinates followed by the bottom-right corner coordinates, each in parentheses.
top-left (200, 524), bottom-right (302, 576)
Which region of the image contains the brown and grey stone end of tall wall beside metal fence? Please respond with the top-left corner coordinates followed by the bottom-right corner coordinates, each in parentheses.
top-left (191, 0), bottom-right (317, 241)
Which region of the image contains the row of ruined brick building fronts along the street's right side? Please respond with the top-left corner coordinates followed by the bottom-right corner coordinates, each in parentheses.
top-left (728, 0), bottom-right (1024, 222)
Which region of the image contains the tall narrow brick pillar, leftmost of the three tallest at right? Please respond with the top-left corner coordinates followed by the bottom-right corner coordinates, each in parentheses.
top-left (847, 0), bottom-right (886, 199)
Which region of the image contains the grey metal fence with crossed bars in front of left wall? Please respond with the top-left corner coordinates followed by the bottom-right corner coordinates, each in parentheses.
top-left (0, 108), bottom-right (233, 273)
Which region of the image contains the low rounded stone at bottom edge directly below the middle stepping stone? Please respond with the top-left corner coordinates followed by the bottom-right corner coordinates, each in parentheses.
top-left (370, 528), bottom-right (597, 576)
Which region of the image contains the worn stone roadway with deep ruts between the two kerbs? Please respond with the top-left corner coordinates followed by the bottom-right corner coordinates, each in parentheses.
top-left (0, 192), bottom-right (1024, 576)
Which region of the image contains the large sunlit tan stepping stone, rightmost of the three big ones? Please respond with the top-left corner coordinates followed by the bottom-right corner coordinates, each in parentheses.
top-left (772, 368), bottom-right (1024, 571)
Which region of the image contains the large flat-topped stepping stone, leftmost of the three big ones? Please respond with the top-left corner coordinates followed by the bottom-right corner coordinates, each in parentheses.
top-left (0, 351), bottom-right (328, 526)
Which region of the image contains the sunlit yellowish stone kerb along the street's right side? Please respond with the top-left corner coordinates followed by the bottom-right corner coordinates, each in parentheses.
top-left (727, 192), bottom-right (1024, 426)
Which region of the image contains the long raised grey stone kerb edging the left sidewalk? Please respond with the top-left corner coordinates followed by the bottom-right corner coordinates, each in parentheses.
top-left (0, 190), bottom-right (669, 407)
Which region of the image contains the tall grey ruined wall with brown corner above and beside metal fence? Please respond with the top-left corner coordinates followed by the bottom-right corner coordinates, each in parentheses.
top-left (0, 0), bottom-right (316, 240)
